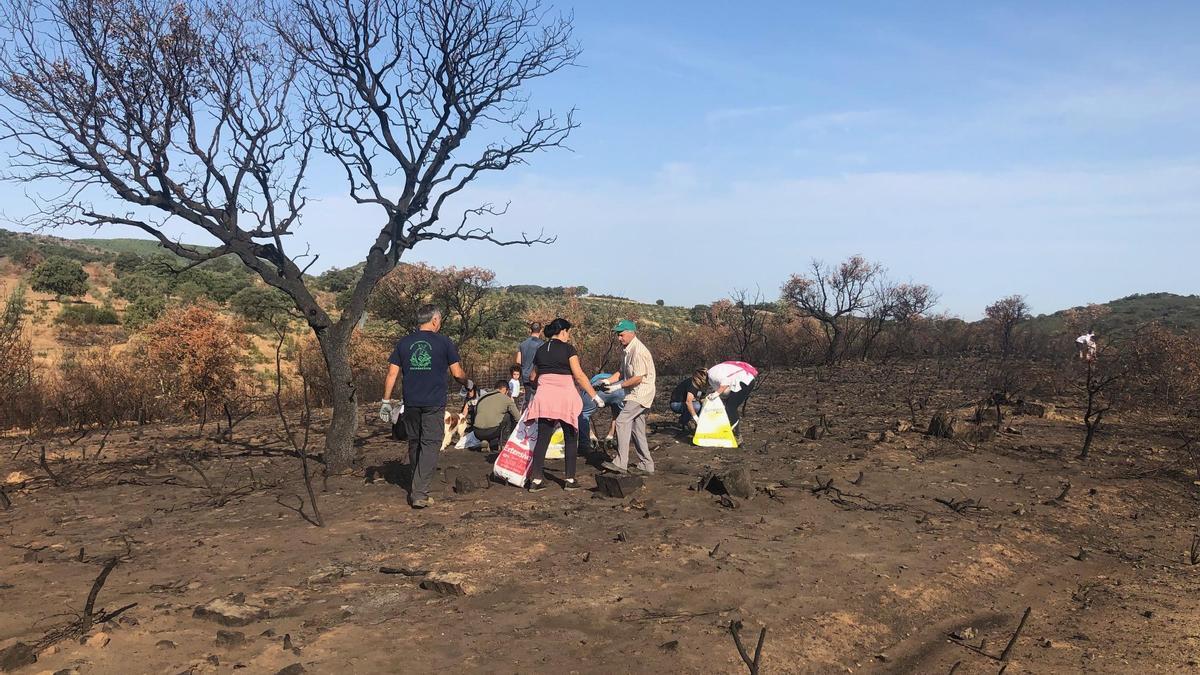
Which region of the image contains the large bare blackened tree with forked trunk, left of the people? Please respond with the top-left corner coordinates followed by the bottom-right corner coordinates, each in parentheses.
top-left (0, 0), bottom-right (578, 470)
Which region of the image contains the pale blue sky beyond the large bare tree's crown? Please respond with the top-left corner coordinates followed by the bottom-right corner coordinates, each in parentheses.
top-left (5, 1), bottom-right (1200, 318)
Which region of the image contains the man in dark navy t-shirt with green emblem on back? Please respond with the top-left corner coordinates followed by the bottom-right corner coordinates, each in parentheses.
top-left (379, 305), bottom-right (475, 508)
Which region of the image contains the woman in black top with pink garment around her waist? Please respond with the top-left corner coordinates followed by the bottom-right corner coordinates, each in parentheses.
top-left (526, 318), bottom-right (604, 492)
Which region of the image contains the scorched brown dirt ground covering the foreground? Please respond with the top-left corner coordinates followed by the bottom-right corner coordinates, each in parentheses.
top-left (0, 368), bottom-right (1200, 674)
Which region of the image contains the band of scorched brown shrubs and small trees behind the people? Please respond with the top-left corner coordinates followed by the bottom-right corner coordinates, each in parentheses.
top-left (9, 249), bottom-right (1200, 466)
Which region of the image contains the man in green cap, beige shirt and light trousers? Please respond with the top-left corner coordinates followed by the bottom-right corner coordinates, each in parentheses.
top-left (599, 318), bottom-right (654, 474)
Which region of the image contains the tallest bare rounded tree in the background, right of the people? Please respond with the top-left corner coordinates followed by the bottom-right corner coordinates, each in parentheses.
top-left (782, 256), bottom-right (883, 365)
